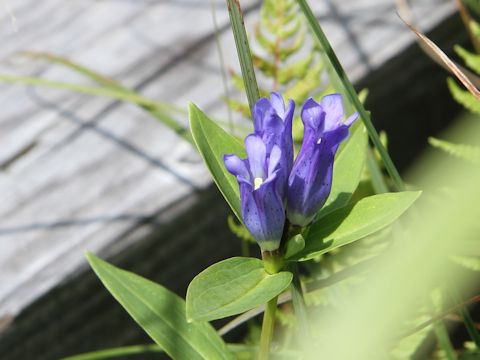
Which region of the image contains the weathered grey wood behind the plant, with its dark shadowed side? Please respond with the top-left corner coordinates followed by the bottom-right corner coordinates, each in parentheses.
top-left (0, 0), bottom-right (464, 359)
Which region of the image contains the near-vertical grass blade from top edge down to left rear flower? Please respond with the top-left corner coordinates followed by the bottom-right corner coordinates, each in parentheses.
top-left (227, 0), bottom-right (260, 112)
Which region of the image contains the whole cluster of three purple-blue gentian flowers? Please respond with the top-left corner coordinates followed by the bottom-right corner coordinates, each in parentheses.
top-left (224, 93), bottom-right (358, 251)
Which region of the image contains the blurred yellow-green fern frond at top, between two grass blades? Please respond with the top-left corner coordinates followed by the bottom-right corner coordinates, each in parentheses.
top-left (229, 0), bottom-right (326, 118)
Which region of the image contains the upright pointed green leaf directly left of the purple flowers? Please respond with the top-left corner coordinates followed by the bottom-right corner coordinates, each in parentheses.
top-left (188, 104), bottom-right (245, 221)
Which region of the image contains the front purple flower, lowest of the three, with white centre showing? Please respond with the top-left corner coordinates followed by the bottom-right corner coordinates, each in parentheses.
top-left (223, 134), bottom-right (285, 251)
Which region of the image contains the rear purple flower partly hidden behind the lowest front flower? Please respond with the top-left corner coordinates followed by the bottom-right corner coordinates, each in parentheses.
top-left (253, 92), bottom-right (295, 187)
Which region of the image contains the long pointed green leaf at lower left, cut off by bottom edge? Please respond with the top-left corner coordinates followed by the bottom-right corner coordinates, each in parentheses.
top-left (87, 253), bottom-right (232, 360)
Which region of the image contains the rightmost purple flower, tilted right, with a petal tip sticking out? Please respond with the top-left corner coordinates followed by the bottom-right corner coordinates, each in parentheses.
top-left (287, 94), bottom-right (358, 226)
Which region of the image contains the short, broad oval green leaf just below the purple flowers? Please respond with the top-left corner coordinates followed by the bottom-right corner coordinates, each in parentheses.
top-left (187, 257), bottom-right (292, 321)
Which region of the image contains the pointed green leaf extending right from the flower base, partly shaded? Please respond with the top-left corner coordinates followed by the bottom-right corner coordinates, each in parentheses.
top-left (294, 191), bottom-right (420, 261)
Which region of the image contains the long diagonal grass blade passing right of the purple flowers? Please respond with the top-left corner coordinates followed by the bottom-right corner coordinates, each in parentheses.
top-left (297, 0), bottom-right (405, 191)
